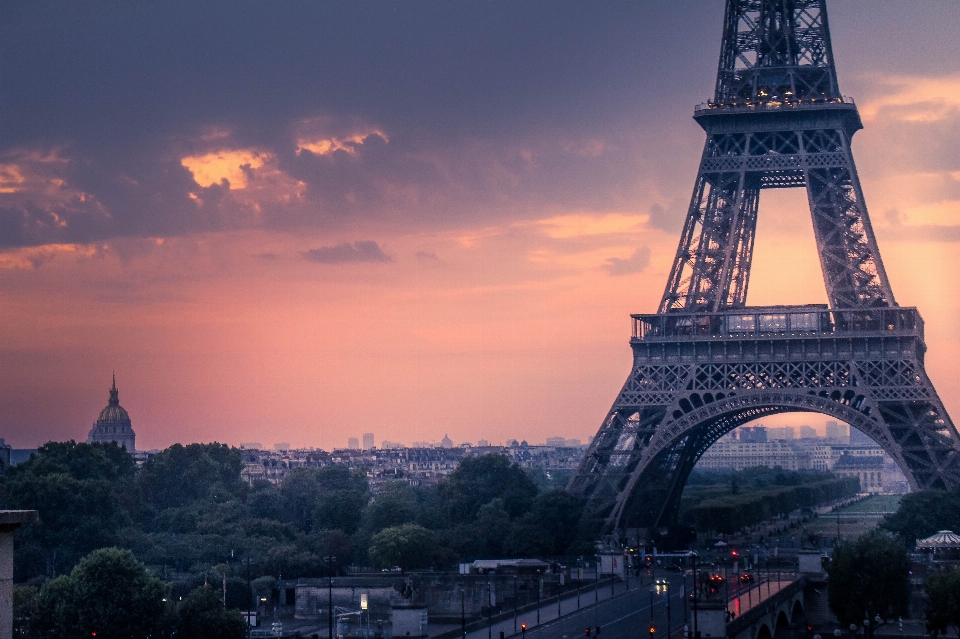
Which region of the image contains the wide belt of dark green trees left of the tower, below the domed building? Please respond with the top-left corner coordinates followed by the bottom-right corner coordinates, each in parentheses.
top-left (0, 441), bottom-right (591, 584)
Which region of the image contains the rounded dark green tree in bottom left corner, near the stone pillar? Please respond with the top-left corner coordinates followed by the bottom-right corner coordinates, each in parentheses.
top-left (30, 548), bottom-right (164, 639)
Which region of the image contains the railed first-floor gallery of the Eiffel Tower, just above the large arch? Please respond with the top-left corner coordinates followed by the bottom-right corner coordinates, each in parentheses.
top-left (630, 306), bottom-right (923, 341)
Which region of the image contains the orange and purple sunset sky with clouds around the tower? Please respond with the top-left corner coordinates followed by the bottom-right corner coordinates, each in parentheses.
top-left (0, 0), bottom-right (960, 449)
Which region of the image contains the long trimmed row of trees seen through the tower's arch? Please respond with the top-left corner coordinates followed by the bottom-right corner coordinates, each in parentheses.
top-left (681, 468), bottom-right (860, 534)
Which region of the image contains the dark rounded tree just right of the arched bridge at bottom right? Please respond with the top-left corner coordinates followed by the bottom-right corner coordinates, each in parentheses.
top-left (827, 531), bottom-right (910, 625)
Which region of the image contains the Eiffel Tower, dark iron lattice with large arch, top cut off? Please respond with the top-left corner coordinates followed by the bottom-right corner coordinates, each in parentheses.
top-left (567, 0), bottom-right (960, 534)
